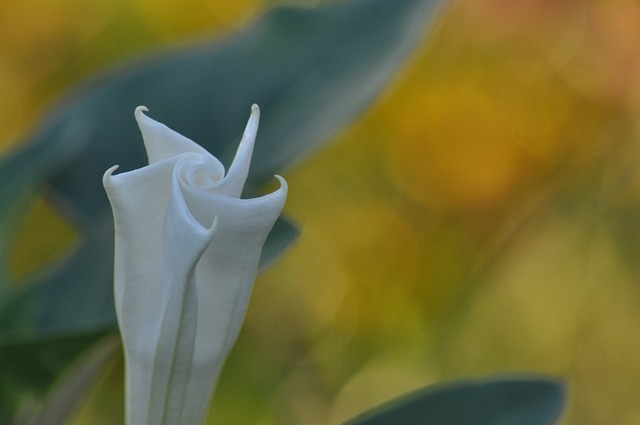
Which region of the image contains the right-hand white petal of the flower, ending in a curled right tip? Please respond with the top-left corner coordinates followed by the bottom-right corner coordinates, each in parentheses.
top-left (175, 178), bottom-right (287, 424)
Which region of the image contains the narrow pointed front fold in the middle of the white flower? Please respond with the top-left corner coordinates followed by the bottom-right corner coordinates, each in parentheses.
top-left (148, 170), bottom-right (216, 425)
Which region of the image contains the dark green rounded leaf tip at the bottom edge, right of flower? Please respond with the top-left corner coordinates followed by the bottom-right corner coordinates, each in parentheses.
top-left (346, 377), bottom-right (566, 425)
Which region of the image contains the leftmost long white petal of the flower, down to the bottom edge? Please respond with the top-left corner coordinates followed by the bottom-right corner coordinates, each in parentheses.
top-left (103, 158), bottom-right (177, 424)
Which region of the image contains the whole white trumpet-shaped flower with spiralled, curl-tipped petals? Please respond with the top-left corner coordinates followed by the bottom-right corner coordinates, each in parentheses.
top-left (103, 105), bottom-right (287, 425)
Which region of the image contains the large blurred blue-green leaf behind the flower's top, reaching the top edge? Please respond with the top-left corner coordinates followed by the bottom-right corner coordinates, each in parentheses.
top-left (45, 0), bottom-right (438, 216)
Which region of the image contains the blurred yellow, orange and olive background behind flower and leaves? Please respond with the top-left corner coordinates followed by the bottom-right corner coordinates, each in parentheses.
top-left (0, 0), bottom-right (640, 425)
